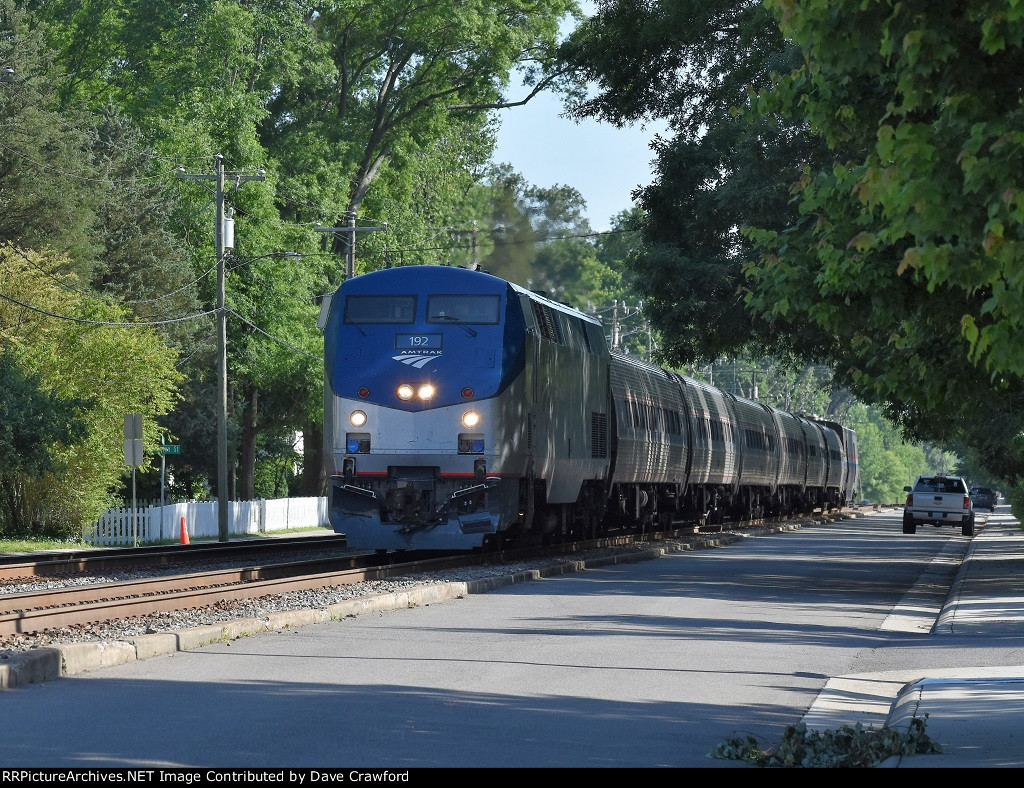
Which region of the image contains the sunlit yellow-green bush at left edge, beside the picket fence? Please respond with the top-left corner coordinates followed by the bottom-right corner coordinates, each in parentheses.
top-left (0, 246), bottom-right (180, 536)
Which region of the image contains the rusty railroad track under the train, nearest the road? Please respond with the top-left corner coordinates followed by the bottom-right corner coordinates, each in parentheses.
top-left (0, 516), bottom-right (856, 638)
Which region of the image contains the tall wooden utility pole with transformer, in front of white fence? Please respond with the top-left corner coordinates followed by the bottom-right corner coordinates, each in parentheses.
top-left (177, 154), bottom-right (266, 541)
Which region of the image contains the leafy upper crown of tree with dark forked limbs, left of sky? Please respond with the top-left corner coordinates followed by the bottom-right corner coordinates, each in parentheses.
top-left (267, 0), bottom-right (577, 233)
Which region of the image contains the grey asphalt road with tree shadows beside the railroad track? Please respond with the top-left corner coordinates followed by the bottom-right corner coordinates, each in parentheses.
top-left (0, 512), bottom-right (1022, 770)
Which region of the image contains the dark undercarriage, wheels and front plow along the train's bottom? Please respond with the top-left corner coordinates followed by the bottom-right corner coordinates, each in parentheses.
top-left (331, 468), bottom-right (840, 550)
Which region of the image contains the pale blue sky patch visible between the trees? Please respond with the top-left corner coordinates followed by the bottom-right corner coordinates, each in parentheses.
top-left (494, 2), bottom-right (667, 231)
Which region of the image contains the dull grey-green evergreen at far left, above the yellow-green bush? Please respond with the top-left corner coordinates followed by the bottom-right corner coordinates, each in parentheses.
top-left (0, 7), bottom-right (215, 503)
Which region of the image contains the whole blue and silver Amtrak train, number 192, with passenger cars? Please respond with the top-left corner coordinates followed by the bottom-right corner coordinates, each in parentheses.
top-left (322, 265), bottom-right (858, 551)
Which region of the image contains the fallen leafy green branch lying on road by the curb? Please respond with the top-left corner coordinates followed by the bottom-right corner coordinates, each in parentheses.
top-left (709, 714), bottom-right (942, 769)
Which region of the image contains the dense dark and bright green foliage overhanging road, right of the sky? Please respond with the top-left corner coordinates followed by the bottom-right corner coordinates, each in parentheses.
top-left (563, 0), bottom-right (1024, 485)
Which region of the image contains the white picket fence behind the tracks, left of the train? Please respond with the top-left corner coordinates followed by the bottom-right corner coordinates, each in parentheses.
top-left (84, 497), bottom-right (331, 545)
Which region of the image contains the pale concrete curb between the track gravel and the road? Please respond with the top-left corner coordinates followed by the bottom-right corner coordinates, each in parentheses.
top-left (0, 525), bottom-right (774, 691)
